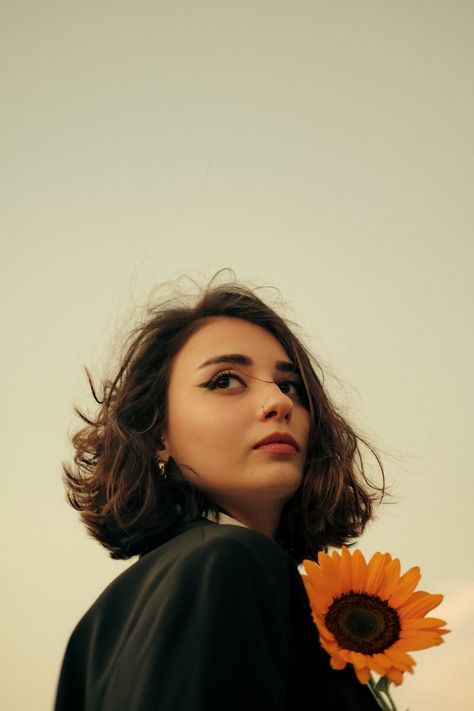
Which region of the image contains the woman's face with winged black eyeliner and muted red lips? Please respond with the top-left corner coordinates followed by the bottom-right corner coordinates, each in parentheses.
top-left (158, 317), bottom-right (310, 511)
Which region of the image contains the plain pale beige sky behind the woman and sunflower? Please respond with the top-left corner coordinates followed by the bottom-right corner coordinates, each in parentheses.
top-left (0, 0), bottom-right (474, 711)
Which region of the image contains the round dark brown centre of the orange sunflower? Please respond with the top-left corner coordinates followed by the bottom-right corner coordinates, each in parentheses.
top-left (324, 592), bottom-right (400, 654)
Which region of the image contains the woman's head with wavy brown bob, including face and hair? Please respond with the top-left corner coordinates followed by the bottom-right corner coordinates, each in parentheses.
top-left (65, 282), bottom-right (384, 559)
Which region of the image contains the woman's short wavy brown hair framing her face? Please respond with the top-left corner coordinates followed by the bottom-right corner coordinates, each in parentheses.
top-left (63, 281), bottom-right (384, 561)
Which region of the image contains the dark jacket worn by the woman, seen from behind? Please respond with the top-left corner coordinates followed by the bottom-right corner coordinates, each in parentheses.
top-left (55, 519), bottom-right (378, 711)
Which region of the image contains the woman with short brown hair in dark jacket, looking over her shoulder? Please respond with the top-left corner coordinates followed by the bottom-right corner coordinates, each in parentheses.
top-left (55, 283), bottom-right (377, 711)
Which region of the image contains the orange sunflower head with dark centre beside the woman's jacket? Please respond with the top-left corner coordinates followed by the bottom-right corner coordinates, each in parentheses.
top-left (302, 546), bottom-right (449, 684)
